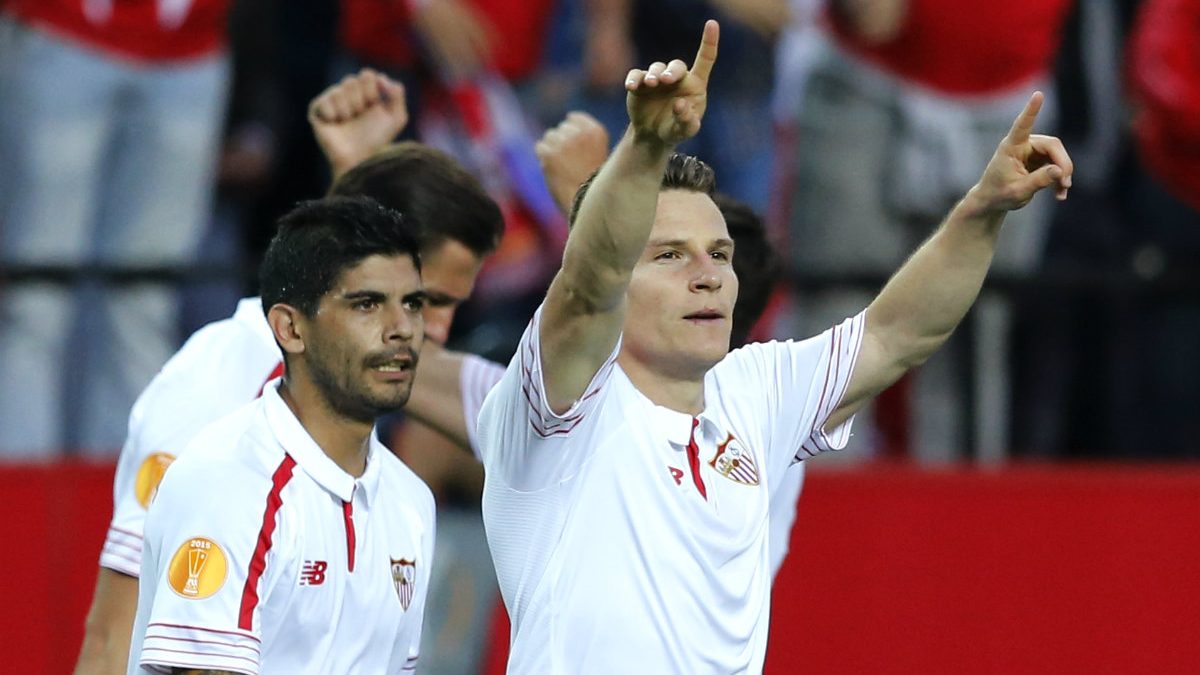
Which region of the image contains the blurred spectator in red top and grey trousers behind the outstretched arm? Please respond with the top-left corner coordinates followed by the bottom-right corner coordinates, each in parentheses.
top-left (788, 0), bottom-right (1070, 460)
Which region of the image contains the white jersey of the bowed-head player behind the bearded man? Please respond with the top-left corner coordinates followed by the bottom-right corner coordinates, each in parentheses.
top-left (100, 298), bottom-right (283, 577)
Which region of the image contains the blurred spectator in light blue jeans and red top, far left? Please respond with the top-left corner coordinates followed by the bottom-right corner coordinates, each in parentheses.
top-left (0, 0), bottom-right (229, 456)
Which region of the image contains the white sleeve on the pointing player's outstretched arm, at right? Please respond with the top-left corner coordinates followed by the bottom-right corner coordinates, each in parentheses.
top-left (733, 312), bottom-right (865, 485)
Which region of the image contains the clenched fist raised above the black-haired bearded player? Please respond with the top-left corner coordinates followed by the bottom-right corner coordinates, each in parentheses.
top-left (308, 68), bottom-right (408, 179)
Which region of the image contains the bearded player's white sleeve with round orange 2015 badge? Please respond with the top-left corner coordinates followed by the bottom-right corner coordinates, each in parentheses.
top-left (139, 456), bottom-right (280, 675)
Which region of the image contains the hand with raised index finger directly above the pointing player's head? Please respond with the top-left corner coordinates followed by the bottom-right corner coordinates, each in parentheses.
top-left (625, 19), bottom-right (720, 145)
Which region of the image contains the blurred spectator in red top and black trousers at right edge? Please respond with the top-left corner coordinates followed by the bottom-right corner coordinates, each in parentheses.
top-left (1127, 0), bottom-right (1200, 459)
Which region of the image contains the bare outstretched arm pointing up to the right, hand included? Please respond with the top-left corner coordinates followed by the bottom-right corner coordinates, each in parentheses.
top-left (826, 92), bottom-right (1074, 429)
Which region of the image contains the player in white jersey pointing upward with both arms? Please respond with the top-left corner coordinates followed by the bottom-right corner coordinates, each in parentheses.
top-left (479, 22), bottom-right (1072, 674)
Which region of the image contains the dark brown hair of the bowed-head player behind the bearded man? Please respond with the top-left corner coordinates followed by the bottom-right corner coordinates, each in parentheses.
top-left (329, 141), bottom-right (504, 257)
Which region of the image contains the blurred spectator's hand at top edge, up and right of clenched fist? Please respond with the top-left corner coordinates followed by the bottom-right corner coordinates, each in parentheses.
top-left (413, 0), bottom-right (494, 80)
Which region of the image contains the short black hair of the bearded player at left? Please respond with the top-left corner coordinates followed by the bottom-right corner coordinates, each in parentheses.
top-left (258, 197), bottom-right (421, 317)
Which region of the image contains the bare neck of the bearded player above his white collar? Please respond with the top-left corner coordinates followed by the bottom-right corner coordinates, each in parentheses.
top-left (280, 377), bottom-right (374, 478)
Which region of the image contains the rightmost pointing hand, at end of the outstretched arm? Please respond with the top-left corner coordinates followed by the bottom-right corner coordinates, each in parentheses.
top-left (971, 91), bottom-right (1075, 213)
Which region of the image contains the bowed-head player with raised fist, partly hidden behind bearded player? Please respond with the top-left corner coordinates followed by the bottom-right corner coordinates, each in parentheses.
top-left (76, 71), bottom-right (504, 675)
